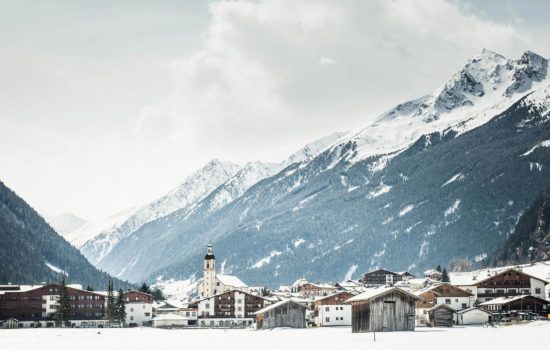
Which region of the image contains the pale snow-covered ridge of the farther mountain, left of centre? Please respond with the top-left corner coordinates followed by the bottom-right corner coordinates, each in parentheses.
top-left (80, 160), bottom-right (239, 264)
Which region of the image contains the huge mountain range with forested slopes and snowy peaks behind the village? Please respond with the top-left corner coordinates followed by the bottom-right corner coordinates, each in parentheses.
top-left (64, 50), bottom-right (550, 286)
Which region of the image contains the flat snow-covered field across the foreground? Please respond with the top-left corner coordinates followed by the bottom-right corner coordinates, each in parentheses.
top-left (0, 321), bottom-right (550, 350)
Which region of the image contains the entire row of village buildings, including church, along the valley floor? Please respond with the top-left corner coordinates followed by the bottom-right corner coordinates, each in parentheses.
top-left (0, 244), bottom-right (550, 332)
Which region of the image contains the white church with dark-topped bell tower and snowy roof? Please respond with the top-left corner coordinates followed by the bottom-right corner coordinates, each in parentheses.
top-left (197, 244), bottom-right (248, 298)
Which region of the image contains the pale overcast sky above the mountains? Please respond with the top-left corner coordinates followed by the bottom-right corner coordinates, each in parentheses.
top-left (0, 0), bottom-right (550, 220)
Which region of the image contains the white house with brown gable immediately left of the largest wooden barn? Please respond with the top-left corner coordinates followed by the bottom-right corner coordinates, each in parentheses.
top-left (313, 290), bottom-right (358, 327)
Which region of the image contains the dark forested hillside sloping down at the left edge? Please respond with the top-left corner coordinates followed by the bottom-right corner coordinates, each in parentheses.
top-left (0, 182), bottom-right (132, 289)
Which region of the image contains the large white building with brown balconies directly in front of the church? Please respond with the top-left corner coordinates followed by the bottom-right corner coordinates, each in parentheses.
top-left (189, 290), bottom-right (271, 327)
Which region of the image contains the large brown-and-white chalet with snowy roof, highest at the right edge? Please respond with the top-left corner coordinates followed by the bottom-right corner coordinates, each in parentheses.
top-left (450, 268), bottom-right (548, 303)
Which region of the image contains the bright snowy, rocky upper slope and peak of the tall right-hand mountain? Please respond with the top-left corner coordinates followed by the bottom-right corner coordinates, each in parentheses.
top-left (326, 49), bottom-right (549, 167)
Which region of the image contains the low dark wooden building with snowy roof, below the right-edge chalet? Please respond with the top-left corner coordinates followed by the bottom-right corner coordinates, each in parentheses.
top-left (479, 295), bottom-right (550, 320)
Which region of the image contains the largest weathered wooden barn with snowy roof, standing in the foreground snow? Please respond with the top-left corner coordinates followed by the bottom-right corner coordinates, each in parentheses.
top-left (346, 287), bottom-right (420, 333)
